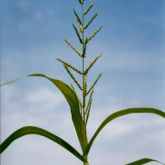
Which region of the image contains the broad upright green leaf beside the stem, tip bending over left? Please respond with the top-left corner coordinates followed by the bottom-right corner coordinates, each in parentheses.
top-left (29, 73), bottom-right (88, 151)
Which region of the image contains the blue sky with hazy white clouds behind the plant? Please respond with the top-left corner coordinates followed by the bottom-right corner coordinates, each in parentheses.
top-left (0, 0), bottom-right (165, 165)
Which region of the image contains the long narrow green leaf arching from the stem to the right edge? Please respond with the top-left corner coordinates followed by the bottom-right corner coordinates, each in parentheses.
top-left (84, 108), bottom-right (165, 156)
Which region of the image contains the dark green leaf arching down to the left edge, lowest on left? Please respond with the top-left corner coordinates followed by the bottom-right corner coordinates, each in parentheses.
top-left (0, 126), bottom-right (85, 162)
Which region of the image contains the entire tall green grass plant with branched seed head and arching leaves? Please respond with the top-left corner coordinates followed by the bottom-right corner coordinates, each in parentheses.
top-left (0, 0), bottom-right (165, 165)
